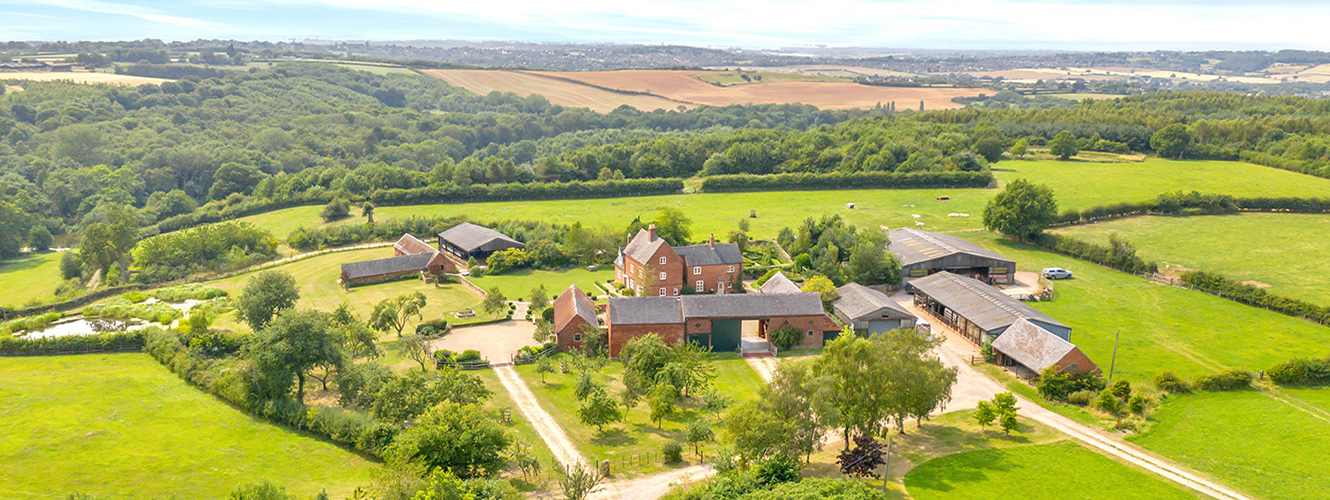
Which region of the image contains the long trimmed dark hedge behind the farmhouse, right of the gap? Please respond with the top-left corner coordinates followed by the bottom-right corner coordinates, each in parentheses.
top-left (702, 172), bottom-right (996, 193)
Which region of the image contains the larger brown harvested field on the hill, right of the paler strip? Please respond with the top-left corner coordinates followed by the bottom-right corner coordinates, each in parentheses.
top-left (532, 69), bottom-right (983, 109)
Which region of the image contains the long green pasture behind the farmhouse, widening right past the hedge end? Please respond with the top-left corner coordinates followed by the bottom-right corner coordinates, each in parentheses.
top-left (242, 158), bottom-right (1330, 241)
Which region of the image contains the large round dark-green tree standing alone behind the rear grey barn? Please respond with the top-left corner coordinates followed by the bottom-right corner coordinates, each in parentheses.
top-left (984, 178), bottom-right (1057, 241)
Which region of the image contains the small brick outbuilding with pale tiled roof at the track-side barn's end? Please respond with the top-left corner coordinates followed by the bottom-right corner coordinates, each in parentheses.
top-left (992, 319), bottom-right (1100, 376)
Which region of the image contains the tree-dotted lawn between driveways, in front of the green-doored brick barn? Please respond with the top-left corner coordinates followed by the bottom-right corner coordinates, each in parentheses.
top-left (517, 354), bottom-right (763, 476)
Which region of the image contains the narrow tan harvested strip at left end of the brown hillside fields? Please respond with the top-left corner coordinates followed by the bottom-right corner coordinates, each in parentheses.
top-left (422, 69), bottom-right (686, 113)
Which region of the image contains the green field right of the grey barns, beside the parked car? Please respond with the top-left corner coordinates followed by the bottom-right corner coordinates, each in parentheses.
top-left (960, 231), bottom-right (1330, 383)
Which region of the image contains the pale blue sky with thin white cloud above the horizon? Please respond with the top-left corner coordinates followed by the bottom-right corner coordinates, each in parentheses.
top-left (0, 0), bottom-right (1330, 51)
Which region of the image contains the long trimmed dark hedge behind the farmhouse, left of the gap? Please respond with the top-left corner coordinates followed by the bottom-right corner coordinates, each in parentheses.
top-left (370, 178), bottom-right (684, 206)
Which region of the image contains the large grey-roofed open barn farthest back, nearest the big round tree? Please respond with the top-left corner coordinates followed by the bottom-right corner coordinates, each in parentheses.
top-left (887, 227), bottom-right (1016, 285)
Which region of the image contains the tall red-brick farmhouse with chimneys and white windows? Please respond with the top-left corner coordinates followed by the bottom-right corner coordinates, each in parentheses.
top-left (614, 225), bottom-right (743, 297)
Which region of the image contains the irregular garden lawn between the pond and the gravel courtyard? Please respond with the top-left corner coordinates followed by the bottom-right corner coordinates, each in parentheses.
top-left (206, 246), bottom-right (491, 332)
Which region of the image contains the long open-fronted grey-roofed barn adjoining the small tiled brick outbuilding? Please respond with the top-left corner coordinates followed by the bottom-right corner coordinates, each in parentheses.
top-left (910, 271), bottom-right (1072, 344)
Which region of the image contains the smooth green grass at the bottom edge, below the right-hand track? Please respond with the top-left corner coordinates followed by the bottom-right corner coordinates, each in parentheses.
top-left (904, 441), bottom-right (1197, 500)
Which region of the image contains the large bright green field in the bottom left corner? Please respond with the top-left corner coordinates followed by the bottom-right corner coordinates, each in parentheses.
top-left (0, 354), bottom-right (379, 499)
